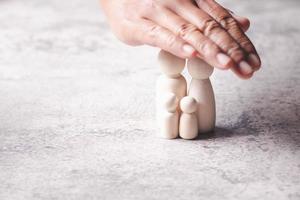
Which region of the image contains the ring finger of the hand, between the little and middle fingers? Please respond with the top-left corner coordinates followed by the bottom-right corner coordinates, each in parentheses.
top-left (145, 8), bottom-right (235, 69)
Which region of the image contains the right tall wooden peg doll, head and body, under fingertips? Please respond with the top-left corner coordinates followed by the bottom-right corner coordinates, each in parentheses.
top-left (187, 58), bottom-right (216, 133)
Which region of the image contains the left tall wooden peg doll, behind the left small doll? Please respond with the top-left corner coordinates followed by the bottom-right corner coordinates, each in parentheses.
top-left (156, 50), bottom-right (187, 139)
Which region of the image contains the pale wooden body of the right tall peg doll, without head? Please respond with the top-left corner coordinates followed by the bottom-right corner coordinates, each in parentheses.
top-left (188, 79), bottom-right (216, 133)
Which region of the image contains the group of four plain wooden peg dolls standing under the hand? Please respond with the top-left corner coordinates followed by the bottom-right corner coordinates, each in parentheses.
top-left (156, 50), bottom-right (216, 139)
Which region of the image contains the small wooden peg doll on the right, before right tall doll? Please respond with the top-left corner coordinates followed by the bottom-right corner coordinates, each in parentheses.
top-left (179, 96), bottom-right (198, 140)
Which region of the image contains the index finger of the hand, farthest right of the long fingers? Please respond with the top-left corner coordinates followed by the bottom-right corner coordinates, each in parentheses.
top-left (196, 0), bottom-right (261, 70)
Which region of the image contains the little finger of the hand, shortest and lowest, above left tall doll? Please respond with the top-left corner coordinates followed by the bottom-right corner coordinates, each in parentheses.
top-left (135, 19), bottom-right (196, 58)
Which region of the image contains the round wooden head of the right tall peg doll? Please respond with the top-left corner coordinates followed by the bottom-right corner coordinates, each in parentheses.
top-left (187, 58), bottom-right (214, 79)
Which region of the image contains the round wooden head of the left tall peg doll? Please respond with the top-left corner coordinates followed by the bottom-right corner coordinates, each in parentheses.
top-left (158, 50), bottom-right (185, 77)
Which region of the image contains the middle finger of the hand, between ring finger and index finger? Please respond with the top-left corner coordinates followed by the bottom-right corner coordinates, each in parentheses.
top-left (168, 3), bottom-right (250, 72)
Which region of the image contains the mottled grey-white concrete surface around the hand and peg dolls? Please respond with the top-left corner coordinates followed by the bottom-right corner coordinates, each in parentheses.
top-left (0, 0), bottom-right (300, 200)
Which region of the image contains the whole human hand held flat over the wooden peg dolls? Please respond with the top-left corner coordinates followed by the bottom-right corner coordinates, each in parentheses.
top-left (100, 0), bottom-right (261, 79)
